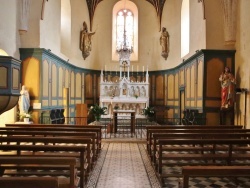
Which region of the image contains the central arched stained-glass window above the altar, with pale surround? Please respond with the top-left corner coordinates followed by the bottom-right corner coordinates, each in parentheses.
top-left (112, 0), bottom-right (138, 61)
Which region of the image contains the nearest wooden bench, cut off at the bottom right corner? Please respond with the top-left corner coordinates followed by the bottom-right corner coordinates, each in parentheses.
top-left (182, 166), bottom-right (250, 188)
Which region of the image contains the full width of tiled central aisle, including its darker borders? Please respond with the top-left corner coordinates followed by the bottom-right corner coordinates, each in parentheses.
top-left (87, 142), bottom-right (161, 188)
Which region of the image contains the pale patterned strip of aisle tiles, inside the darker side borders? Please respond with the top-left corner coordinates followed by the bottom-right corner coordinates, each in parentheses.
top-left (97, 143), bottom-right (158, 188)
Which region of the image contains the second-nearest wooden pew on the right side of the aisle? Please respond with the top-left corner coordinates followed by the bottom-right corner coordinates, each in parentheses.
top-left (156, 139), bottom-right (250, 183)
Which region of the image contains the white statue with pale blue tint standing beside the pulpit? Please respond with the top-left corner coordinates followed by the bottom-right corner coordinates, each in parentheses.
top-left (19, 85), bottom-right (30, 114)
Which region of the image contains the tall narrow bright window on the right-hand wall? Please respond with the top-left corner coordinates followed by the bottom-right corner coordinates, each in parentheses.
top-left (181, 0), bottom-right (190, 57)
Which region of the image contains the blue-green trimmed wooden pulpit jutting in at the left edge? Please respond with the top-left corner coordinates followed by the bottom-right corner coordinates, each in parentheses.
top-left (0, 56), bottom-right (21, 115)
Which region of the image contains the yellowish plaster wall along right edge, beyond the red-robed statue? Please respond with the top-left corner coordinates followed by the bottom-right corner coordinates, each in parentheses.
top-left (235, 0), bottom-right (250, 128)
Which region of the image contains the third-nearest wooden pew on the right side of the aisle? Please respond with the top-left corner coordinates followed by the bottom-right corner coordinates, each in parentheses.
top-left (149, 131), bottom-right (250, 164)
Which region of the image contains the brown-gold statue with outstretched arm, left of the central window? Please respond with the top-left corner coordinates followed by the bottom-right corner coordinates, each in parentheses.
top-left (80, 22), bottom-right (95, 60)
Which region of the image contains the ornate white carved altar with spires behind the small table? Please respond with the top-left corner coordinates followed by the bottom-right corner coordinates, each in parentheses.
top-left (100, 70), bottom-right (149, 118)
